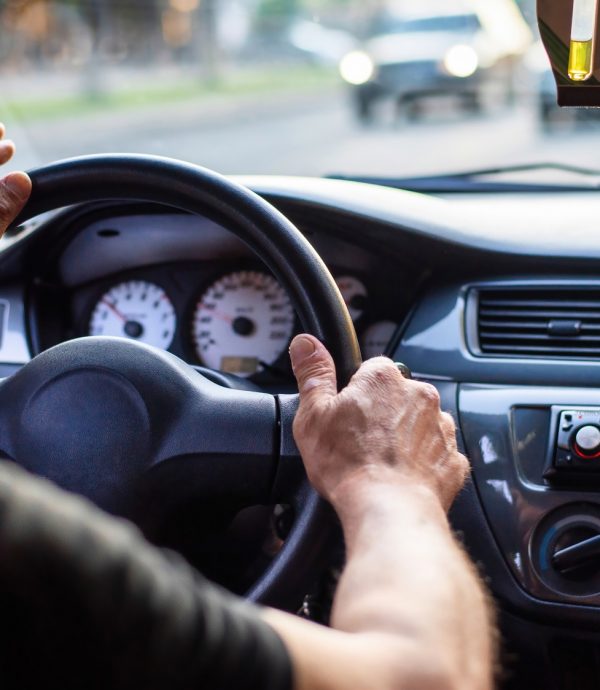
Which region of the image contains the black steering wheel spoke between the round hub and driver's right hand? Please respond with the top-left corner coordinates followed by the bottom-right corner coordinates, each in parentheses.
top-left (143, 374), bottom-right (278, 507)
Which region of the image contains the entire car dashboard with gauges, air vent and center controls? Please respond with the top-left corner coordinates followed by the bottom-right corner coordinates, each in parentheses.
top-left (0, 177), bottom-right (600, 690)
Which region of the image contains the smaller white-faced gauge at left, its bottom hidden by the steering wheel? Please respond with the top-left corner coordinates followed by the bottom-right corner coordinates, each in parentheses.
top-left (89, 280), bottom-right (177, 350)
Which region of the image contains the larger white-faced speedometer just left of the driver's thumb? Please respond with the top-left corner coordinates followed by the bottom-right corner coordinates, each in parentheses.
top-left (192, 271), bottom-right (294, 376)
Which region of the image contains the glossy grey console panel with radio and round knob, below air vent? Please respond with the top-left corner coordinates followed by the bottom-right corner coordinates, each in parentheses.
top-left (459, 385), bottom-right (600, 605)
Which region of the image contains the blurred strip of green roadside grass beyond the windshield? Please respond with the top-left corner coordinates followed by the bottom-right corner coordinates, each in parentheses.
top-left (2, 65), bottom-right (338, 122)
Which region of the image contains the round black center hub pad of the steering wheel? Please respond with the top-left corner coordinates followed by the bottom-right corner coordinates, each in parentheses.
top-left (17, 366), bottom-right (150, 514)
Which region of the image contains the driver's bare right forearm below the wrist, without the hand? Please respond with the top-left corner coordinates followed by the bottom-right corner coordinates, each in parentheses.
top-left (332, 468), bottom-right (494, 690)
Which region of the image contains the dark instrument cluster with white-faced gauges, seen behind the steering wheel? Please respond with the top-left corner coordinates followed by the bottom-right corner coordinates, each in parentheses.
top-left (24, 208), bottom-right (419, 388)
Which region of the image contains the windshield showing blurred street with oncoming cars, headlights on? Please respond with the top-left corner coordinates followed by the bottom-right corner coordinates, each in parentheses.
top-left (0, 0), bottom-right (600, 178)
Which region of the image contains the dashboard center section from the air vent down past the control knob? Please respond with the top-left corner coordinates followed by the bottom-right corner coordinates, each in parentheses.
top-left (393, 280), bottom-right (600, 690)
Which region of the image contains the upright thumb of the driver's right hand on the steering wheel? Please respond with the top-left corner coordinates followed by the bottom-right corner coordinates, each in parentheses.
top-left (290, 334), bottom-right (337, 404)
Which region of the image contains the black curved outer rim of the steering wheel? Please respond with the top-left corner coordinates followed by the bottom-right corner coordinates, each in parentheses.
top-left (9, 155), bottom-right (360, 608)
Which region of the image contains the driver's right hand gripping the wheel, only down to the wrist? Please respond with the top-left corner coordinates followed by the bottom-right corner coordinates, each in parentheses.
top-left (290, 335), bottom-right (469, 510)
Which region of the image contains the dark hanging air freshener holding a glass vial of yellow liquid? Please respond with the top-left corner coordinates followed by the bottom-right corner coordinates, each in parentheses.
top-left (538, 0), bottom-right (600, 107)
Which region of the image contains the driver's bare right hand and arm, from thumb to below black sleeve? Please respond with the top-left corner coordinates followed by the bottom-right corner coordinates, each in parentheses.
top-left (267, 335), bottom-right (494, 690)
